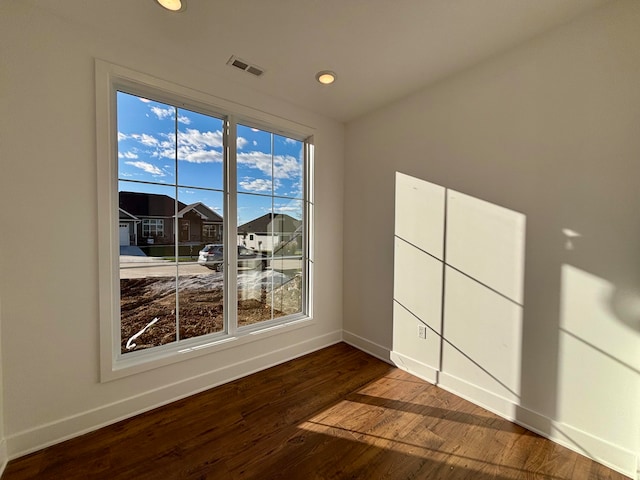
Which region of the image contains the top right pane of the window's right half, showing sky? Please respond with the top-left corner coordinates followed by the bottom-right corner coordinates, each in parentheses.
top-left (273, 135), bottom-right (304, 198)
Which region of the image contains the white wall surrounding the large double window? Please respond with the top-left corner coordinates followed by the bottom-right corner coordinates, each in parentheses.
top-left (0, 2), bottom-right (344, 457)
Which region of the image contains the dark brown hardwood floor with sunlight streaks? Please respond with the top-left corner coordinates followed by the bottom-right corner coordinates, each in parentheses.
top-left (2, 343), bottom-right (627, 480)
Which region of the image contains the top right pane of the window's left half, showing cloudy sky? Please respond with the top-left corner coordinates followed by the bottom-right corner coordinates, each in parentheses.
top-left (178, 109), bottom-right (224, 190)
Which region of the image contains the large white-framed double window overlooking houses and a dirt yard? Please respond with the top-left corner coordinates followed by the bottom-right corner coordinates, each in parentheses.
top-left (98, 60), bottom-right (311, 378)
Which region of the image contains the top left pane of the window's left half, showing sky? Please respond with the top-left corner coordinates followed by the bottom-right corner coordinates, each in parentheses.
top-left (117, 92), bottom-right (176, 183)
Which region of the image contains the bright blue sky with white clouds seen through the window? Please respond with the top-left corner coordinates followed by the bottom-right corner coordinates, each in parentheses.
top-left (118, 92), bottom-right (303, 225)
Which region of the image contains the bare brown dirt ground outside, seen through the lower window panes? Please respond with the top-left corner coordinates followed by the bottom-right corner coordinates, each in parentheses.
top-left (120, 276), bottom-right (301, 353)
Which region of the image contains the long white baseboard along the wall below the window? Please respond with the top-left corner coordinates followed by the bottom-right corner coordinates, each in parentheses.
top-left (4, 330), bottom-right (342, 460)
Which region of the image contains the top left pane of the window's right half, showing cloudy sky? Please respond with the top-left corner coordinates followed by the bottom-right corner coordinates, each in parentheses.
top-left (236, 125), bottom-right (273, 195)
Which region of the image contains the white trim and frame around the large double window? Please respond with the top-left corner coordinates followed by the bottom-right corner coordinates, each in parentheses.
top-left (95, 59), bottom-right (314, 382)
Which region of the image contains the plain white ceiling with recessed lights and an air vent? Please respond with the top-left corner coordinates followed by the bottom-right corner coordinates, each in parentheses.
top-left (31, 0), bottom-right (610, 121)
